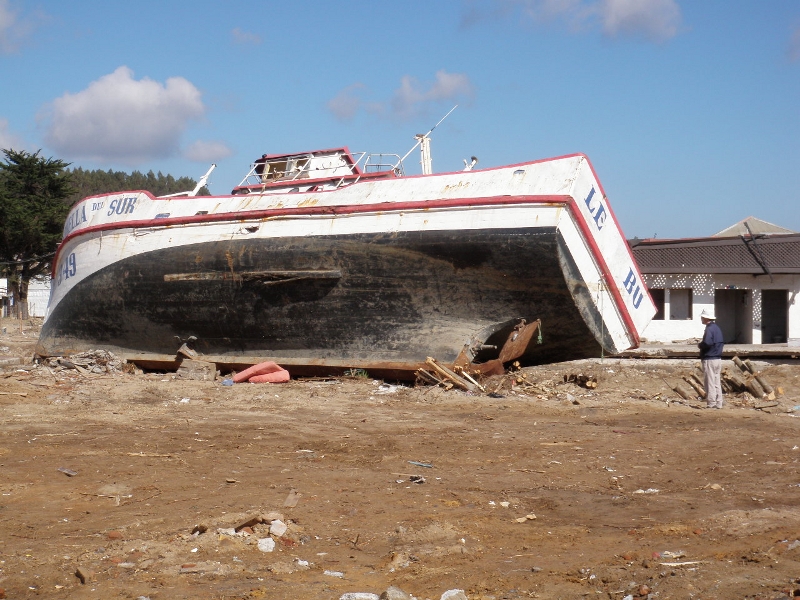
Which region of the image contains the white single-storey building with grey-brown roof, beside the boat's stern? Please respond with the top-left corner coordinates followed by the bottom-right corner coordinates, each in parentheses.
top-left (630, 217), bottom-right (800, 346)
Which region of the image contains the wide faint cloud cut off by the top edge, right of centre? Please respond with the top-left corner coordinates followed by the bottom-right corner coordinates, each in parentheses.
top-left (462, 0), bottom-right (681, 42)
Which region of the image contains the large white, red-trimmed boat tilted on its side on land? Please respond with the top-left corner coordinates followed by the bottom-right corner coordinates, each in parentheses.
top-left (37, 136), bottom-right (655, 373)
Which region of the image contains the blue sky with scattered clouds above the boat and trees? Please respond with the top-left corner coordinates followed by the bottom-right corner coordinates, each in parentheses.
top-left (0, 0), bottom-right (800, 238)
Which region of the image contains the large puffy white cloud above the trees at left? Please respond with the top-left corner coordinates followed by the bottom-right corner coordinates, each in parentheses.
top-left (45, 66), bottom-right (205, 166)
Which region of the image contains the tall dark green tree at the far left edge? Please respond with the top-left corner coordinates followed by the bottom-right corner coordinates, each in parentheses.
top-left (0, 150), bottom-right (74, 319)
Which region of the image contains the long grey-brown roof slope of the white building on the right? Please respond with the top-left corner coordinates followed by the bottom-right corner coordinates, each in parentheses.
top-left (629, 232), bottom-right (800, 275)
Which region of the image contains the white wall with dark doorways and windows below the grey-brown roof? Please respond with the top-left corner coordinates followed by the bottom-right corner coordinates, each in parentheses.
top-left (642, 274), bottom-right (800, 346)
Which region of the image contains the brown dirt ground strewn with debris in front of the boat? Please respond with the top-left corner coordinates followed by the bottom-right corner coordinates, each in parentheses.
top-left (0, 320), bottom-right (800, 600)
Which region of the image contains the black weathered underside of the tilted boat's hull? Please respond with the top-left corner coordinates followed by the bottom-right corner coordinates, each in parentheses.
top-left (37, 228), bottom-right (611, 369)
